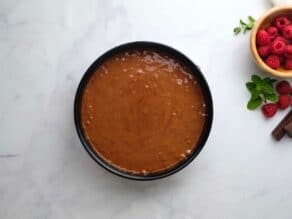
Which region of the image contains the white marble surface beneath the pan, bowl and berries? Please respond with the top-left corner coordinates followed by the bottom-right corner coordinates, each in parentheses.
top-left (0, 0), bottom-right (292, 219)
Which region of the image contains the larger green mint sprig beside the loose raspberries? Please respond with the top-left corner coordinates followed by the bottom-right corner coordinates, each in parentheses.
top-left (245, 75), bottom-right (278, 110)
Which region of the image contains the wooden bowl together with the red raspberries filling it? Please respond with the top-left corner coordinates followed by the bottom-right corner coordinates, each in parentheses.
top-left (250, 6), bottom-right (292, 78)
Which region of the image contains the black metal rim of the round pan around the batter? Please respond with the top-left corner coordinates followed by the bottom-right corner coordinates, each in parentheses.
top-left (74, 41), bottom-right (213, 181)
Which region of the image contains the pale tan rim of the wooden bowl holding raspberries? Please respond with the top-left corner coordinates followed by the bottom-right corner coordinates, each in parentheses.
top-left (250, 5), bottom-right (292, 78)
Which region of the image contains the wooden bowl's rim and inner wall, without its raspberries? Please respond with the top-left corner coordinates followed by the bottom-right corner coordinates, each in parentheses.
top-left (250, 5), bottom-right (292, 78)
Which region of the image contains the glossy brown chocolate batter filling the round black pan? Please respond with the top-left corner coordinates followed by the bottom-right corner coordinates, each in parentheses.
top-left (81, 50), bottom-right (206, 175)
